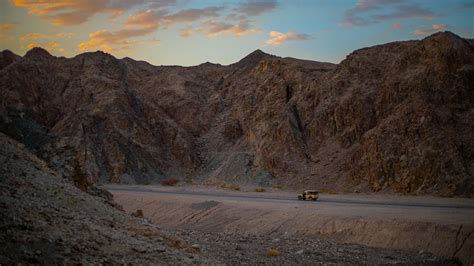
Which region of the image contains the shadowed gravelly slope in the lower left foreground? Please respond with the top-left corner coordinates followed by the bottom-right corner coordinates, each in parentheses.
top-left (0, 133), bottom-right (207, 265)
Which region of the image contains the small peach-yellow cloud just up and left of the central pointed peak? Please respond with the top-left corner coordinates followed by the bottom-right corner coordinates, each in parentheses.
top-left (198, 20), bottom-right (261, 37)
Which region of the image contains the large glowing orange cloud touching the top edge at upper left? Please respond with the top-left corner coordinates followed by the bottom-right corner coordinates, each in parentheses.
top-left (13, 0), bottom-right (150, 26)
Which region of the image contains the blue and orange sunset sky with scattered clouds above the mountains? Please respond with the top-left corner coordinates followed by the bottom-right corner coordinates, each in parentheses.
top-left (0, 0), bottom-right (474, 66)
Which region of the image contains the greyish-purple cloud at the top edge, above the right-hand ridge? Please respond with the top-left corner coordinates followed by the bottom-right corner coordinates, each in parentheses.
top-left (340, 0), bottom-right (438, 26)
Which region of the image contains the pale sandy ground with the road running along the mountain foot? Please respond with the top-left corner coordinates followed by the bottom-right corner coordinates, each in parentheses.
top-left (105, 185), bottom-right (474, 265)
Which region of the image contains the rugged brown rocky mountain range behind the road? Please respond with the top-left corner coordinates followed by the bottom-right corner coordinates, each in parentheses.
top-left (0, 32), bottom-right (474, 196)
